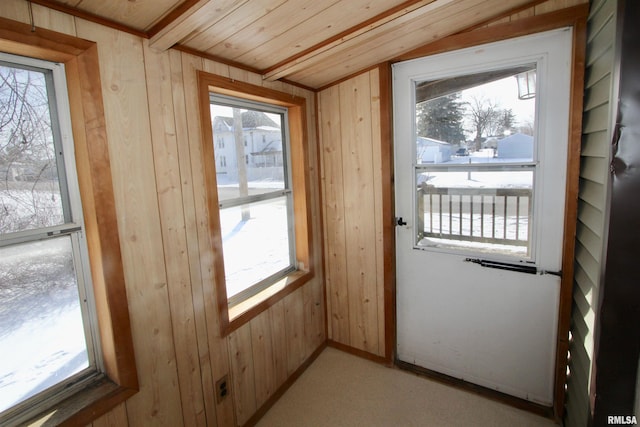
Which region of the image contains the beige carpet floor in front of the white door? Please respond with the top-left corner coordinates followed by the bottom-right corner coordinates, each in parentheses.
top-left (258, 348), bottom-right (556, 427)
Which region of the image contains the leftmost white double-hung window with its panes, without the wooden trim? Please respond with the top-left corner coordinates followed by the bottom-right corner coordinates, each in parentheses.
top-left (0, 53), bottom-right (102, 424)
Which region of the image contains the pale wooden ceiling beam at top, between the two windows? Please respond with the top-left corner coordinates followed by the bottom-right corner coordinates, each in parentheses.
top-left (149, 0), bottom-right (249, 51)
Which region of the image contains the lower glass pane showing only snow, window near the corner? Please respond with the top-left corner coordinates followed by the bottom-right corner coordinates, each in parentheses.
top-left (220, 196), bottom-right (291, 297)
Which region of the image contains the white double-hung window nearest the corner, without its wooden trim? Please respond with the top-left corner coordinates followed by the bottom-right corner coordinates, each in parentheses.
top-left (210, 93), bottom-right (297, 307)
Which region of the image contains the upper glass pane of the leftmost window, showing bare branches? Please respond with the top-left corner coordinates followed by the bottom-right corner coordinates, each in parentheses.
top-left (0, 63), bottom-right (65, 235)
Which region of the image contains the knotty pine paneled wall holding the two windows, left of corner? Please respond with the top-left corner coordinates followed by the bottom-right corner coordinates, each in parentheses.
top-left (0, 0), bottom-right (326, 427)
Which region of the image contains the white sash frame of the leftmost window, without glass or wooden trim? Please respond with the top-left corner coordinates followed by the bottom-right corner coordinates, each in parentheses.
top-left (0, 52), bottom-right (103, 423)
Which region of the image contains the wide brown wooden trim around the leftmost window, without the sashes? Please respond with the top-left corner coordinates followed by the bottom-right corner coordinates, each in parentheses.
top-left (0, 18), bottom-right (139, 425)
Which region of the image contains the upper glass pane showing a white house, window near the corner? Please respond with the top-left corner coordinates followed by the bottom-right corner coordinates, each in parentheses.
top-left (211, 104), bottom-right (285, 202)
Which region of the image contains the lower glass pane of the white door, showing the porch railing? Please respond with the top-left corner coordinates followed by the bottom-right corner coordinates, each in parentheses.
top-left (416, 167), bottom-right (534, 257)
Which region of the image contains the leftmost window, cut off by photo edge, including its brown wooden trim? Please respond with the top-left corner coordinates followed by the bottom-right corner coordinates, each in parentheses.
top-left (0, 18), bottom-right (138, 425)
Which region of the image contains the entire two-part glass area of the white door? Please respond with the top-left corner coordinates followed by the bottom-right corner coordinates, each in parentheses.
top-left (415, 65), bottom-right (536, 258)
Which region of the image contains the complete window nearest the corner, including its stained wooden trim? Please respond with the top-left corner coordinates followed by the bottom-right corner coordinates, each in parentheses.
top-left (199, 72), bottom-right (313, 333)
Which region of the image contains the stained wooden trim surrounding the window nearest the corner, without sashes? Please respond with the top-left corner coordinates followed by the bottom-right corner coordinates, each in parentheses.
top-left (197, 71), bottom-right (314, 336)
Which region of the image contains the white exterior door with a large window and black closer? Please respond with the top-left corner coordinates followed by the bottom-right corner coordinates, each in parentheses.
top-left (393, 29), bottom-right (572, 406)
